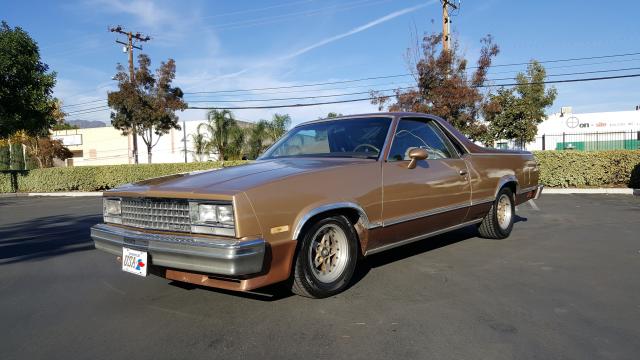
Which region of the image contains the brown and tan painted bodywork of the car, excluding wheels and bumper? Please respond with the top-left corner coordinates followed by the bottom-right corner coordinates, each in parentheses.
top-left (95, 113), bottom-right (538, 291)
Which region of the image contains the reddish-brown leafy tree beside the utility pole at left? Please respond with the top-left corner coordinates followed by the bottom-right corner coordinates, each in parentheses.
top-left (108, 54), bottom-right (187, 163)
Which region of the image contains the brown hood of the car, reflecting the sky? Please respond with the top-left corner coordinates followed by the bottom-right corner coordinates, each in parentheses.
top-left (109, 158), bottom-right (374, 197)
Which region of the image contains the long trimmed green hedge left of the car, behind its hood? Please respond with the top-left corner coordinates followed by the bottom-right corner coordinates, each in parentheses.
top-left (0, 161), bottom-right (246, 192)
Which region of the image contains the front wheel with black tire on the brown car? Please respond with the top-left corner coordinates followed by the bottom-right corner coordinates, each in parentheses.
top-left (291, 215), bottom-right (358, 299)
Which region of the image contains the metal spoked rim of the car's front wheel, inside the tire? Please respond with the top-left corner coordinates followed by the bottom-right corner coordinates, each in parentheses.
top-left (308, 224), bottom-right (349, 283)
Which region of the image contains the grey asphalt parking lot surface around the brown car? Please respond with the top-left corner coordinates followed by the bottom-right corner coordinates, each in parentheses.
top-left (0, 195), bottom-right (640, 359)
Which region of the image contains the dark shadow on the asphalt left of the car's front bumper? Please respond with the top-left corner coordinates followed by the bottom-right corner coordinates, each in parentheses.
top-left (0, 215), bottom-right (102, 265)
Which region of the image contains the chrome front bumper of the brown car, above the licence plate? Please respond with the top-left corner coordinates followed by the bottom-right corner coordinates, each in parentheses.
top-left (91, 224), bottom-right (266, 276)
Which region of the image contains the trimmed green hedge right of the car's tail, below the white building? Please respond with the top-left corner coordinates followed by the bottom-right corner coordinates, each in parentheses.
top-left (534, 150), bottom-right (640, 188)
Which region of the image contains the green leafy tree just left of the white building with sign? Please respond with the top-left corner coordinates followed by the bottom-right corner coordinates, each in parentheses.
top-left (482, 60), bottom-right (557, 146)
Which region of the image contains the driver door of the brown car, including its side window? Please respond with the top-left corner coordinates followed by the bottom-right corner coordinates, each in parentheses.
top-left (377, 118), bottom-right (471, 246)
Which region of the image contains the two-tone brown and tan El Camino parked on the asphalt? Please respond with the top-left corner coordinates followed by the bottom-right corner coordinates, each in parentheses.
top-left (91, 113), bottom-right (542, 298)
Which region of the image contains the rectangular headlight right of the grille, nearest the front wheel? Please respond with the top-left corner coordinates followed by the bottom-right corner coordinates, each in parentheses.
top-left (189, 202), bottom-right (235, 236)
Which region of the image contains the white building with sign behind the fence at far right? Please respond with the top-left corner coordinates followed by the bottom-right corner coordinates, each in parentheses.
top-left (496, 107), bottom-right (640, 151)
